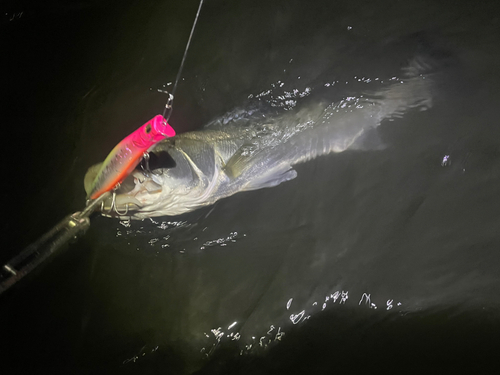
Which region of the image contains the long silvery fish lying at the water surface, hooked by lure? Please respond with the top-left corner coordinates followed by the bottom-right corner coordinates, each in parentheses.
top-left (86, 58), bottom-right (432, 219)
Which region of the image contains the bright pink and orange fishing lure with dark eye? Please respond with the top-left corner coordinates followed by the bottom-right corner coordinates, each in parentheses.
top-left (87, 115), bottom-right (175, 199)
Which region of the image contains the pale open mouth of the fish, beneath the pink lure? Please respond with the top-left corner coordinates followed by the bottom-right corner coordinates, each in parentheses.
top-left (101, 169), bottom-right (163, 218)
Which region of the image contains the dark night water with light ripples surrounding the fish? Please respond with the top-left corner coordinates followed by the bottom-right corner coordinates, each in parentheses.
top-left (0, 0), bottom-right (500, 374)
